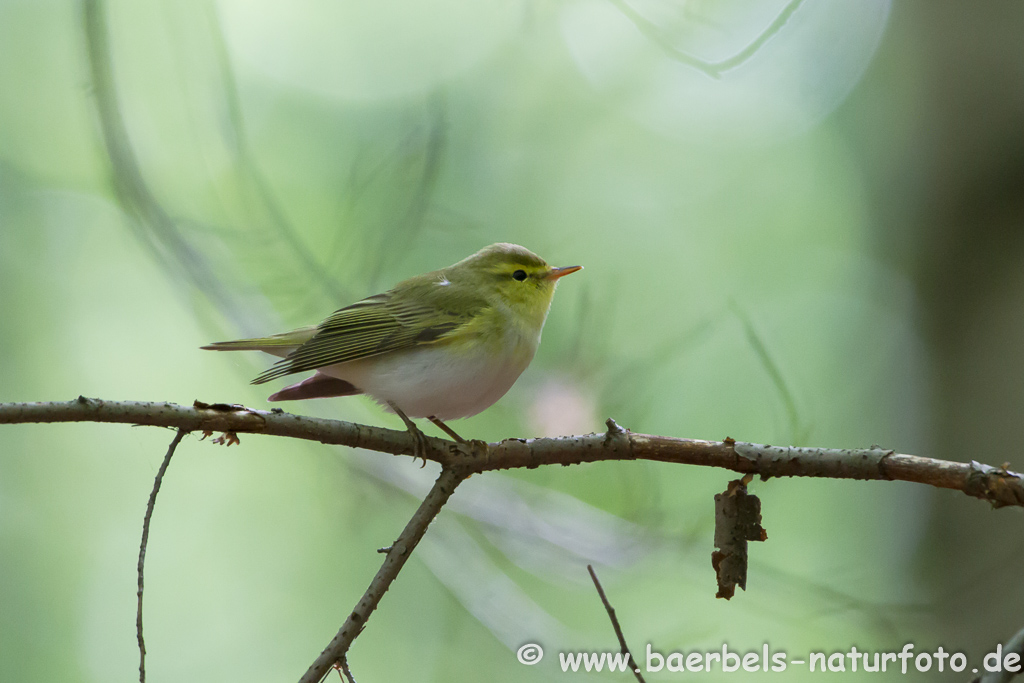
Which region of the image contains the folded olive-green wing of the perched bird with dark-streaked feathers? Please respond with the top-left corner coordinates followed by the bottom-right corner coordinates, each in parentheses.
top-left (252, 290), bottom-right (483, 384)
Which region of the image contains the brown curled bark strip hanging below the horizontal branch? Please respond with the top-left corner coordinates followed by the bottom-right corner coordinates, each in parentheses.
top-left (711, 475), bottom-right (768, 600)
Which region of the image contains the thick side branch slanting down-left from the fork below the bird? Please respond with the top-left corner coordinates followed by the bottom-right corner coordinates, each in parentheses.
top-left (299, 468), bottom-right (469, 683)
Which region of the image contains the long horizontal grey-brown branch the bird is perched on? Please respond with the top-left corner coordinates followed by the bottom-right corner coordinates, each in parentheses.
top-left (0, 396), bottom-right (1024, 507)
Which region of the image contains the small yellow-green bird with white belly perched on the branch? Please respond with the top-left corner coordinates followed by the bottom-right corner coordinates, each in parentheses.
top-left (203, 244), bottom-right (583, 444)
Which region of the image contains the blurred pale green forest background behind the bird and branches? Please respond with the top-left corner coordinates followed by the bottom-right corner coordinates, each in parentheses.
top-left (0, 0), bottom-right (1024, 682)
